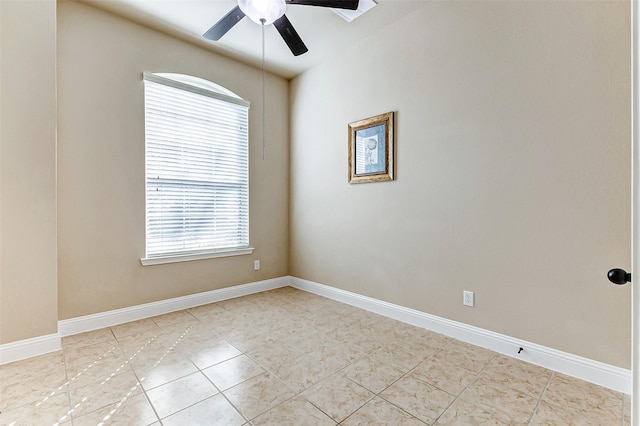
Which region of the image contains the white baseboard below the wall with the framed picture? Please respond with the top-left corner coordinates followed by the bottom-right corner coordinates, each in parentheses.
top-left (289, 277), bottom-right (632, 394)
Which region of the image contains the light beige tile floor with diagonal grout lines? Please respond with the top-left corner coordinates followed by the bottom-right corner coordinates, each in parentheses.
top-left (0, 287), bottom-right (630, 426)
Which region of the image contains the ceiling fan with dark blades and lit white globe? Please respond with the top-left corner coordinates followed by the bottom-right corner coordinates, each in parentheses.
top-left (203, 0), bottom-right (359, 56)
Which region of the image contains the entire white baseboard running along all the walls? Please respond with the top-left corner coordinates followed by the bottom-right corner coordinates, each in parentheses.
top-left (0, 277), bottom-right (632, 394)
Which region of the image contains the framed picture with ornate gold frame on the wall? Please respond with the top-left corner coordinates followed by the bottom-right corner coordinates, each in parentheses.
top-left (349, 111), bottom-right (395, 183)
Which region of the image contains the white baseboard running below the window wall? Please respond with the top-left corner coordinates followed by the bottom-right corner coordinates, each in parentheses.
top-left (58, 277), bottom-right (289, 337)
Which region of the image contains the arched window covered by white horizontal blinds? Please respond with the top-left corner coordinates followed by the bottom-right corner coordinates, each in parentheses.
top-left (142, 73), bottom-right (253, 265)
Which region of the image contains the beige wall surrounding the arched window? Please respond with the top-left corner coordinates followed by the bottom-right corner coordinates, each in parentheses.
top-left (58, 2), bottom-right (289, 320)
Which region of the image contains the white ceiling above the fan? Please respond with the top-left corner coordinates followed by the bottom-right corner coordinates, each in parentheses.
top-left (83, 0), bottom-right (426, 78)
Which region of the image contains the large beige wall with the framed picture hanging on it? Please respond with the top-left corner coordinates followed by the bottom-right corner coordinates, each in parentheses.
top-left (290, 2), bottom-right (631, 368)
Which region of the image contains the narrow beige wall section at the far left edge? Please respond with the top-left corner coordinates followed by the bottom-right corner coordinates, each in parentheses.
top-left (0, 0), bottom-right (58, 344)
